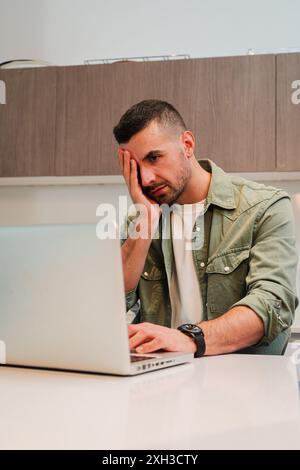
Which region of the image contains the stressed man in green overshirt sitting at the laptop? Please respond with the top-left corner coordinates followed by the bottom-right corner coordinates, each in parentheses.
top-left (114, 100), bottom-right (298, 357)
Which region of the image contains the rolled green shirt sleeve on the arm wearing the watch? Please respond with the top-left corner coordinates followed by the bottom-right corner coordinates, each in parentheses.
top-left (232, 192), bottom-right (298, 344)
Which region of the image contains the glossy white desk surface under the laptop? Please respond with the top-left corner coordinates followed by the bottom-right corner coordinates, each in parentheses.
top-left (0, 355), bottom-right (300, 450)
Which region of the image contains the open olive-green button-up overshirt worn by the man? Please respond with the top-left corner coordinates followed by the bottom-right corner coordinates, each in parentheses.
top-left (126, 160), bottom-right (298, 354)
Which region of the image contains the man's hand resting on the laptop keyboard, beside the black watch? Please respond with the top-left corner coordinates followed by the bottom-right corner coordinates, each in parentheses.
top-left (128, 323), bottom-right (197, 354)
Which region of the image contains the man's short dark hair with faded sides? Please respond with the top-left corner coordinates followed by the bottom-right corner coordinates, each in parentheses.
top-left (113, 100), bottom-right (187, 144)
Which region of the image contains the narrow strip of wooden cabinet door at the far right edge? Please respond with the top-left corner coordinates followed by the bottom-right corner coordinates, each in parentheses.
top-left (276, 54), bottom-right (300, 171)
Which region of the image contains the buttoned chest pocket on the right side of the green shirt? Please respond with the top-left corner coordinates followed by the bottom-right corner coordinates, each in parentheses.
top-left (206, 247), bottom-right (250, 319)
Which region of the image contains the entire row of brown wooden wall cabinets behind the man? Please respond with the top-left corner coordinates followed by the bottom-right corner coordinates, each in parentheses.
top-left (0, 54), bottom-right (300, 176)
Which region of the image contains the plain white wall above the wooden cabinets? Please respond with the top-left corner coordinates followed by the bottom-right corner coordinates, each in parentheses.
top-left (0, 0), bottom-right (300, 65)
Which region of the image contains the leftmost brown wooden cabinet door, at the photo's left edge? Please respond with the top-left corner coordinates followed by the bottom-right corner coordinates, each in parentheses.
top-left (0, 67), bottom-right (56, 176)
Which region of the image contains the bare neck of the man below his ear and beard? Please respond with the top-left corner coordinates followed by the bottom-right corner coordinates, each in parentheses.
top-left (176, 157), bottom-right (212, 204)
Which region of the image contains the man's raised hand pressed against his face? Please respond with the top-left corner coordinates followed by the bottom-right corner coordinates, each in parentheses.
top-left (118, 148), bottom-right (161, 215)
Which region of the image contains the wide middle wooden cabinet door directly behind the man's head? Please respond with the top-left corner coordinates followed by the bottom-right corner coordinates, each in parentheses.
top-left (56, 56), bottom-right (275, 175)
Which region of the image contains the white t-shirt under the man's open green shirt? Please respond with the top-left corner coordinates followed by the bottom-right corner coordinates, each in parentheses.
top-left (170, 200), bottom-right (205, 328)
